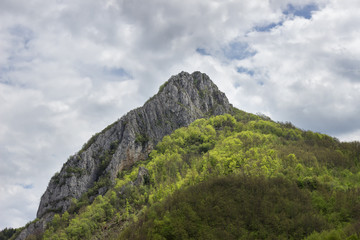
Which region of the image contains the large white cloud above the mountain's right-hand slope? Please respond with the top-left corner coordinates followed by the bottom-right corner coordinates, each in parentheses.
top-left (233, 2), bottom-right (360, 136)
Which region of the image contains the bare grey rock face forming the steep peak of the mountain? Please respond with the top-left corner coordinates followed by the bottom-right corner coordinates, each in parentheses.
top-left (18, 72), bottom-right (232, 239)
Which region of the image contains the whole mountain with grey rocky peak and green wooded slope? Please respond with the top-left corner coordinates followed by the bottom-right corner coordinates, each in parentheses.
top-left (4, 72), bottom-right (360, 240)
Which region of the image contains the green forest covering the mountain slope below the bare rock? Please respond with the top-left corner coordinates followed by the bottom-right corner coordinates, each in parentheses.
top-left (4, 109), bottom-right (360, 240)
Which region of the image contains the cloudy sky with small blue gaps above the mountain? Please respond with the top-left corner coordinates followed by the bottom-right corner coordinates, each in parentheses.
top-left (0, 0), bottom-right (360, 229)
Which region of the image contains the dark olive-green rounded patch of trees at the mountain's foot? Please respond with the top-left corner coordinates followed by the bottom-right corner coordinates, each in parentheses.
top-left (120, 176), bottom-right (328, 239)
